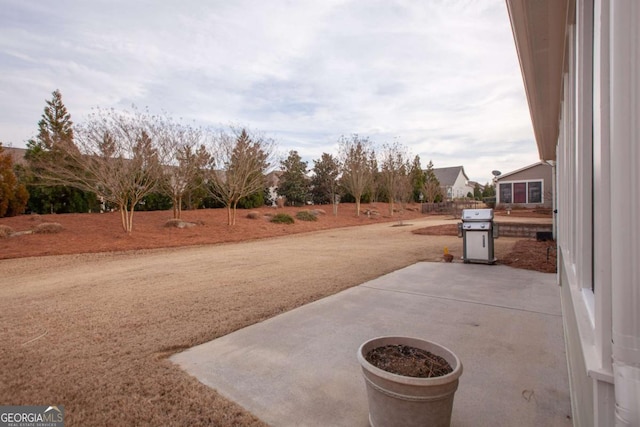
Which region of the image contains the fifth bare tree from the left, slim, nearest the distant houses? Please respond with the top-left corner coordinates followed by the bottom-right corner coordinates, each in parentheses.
top-left (380, 141), bottom-right (410, 216)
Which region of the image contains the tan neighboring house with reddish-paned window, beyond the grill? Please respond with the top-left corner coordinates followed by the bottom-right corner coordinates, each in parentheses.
top-left (496, 162), bottom-right (553, 208)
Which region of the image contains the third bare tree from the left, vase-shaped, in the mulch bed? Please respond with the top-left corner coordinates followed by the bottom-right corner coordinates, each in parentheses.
top-left (207, 128), bottom-right (275, 225)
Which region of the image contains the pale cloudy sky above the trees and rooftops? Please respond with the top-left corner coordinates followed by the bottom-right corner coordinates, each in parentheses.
top-left (0, 0), bottom-right (538, 183)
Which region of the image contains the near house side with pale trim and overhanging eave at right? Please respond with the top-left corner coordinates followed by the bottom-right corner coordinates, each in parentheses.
top-left (506, 0), bottom-right (640, 427)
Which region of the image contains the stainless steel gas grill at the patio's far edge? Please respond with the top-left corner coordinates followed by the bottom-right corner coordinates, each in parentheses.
top-left (458, 209), bottom-right (498, 264)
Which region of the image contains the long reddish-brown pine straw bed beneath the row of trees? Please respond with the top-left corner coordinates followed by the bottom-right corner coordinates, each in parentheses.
top-left (0, 203), bottom-right (423, 259)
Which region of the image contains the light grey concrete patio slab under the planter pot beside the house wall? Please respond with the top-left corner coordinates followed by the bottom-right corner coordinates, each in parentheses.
top-left (171, 262), bottom-right (572, 427)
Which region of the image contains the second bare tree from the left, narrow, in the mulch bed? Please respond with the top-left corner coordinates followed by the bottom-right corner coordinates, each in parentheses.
top-left (159, 120), bottom-right (211, 219)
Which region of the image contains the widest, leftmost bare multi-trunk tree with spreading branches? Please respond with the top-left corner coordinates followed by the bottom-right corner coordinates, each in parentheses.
top-left (30, 108), bottom-right (167, 233)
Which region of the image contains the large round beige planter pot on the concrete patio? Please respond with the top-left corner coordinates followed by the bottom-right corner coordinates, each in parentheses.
top-left (358, 337), bottom-right (462, 427)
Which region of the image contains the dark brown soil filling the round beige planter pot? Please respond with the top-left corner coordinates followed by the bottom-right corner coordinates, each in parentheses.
top-left (365, 345), bottom-right (453, 378)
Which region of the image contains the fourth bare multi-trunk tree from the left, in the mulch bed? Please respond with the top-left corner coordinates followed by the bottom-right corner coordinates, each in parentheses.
top-left (338, 134), bottom-right (375, 216)
